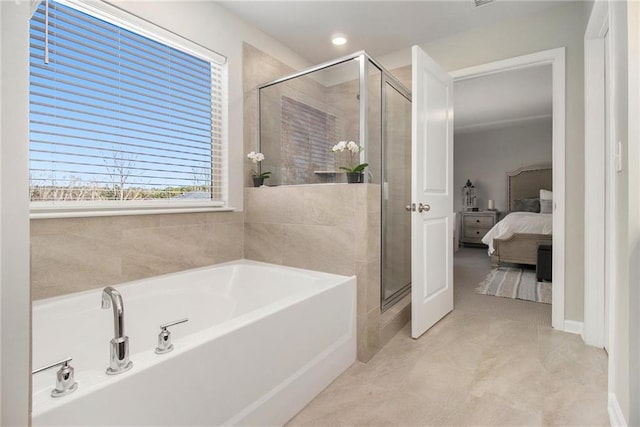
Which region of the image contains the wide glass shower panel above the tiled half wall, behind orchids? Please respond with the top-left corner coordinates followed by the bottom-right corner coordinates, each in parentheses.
top-left (260, 59), bottom-right (361, 185)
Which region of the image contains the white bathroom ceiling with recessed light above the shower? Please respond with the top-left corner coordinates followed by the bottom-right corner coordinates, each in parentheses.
top-left (218, 0), bottom-right (560, 64)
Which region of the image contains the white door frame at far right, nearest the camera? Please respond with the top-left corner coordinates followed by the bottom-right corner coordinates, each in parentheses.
top-left (583, 0), bottom-right (631, 425)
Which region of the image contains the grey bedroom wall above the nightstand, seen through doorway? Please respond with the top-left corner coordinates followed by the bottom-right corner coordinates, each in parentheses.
top-left (453, 119), bottom-right (553, 213)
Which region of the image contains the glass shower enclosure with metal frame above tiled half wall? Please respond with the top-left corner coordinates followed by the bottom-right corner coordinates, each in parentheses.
top-left (258, 52), bottom-right (411, 310)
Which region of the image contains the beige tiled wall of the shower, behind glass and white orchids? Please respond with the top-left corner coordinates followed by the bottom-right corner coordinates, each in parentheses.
top-left (243, 44), bottom-right (359, 185)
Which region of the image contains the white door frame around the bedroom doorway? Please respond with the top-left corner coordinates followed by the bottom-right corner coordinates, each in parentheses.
top-left (451, 47), bottom-right (568, 333)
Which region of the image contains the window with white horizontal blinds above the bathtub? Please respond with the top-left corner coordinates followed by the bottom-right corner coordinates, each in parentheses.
top-left (29, 0), bottom-right (226, 205)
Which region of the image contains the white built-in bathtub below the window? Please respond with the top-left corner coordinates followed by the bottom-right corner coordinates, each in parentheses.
top-left (32, 260), bottom-right (356, 426)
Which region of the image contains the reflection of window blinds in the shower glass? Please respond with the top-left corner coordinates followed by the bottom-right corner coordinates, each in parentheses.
top-left (281, 96), bottom-right (336, 184)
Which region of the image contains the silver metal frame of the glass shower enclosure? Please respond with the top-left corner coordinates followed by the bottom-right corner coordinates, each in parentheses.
top-left (257, 50), bottom-right (411, 312)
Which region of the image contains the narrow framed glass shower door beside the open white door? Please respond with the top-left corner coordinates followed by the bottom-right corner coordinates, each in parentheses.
top-left (380, 79), bottom-right (411, 310)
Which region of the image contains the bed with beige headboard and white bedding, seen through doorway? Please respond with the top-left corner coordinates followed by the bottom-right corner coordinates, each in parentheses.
top-left (482, 166), bottom-right (553, 267)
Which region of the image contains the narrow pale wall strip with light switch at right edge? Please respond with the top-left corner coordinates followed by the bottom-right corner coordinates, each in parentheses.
top-left (609, 1), bottom-right (640, 425)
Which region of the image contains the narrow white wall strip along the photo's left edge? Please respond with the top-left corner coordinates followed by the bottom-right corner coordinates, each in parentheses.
top-left (0, 1), bottom-right (31, 426)
